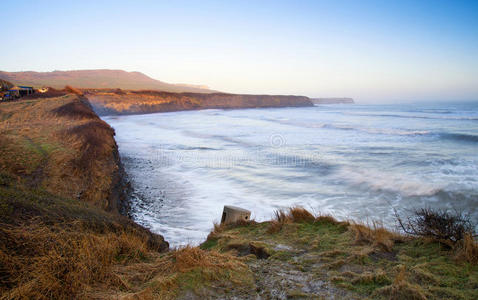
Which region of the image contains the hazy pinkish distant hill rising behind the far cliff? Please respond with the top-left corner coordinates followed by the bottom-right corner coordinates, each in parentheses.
top-left (0, 70), bottom-right (213, 93)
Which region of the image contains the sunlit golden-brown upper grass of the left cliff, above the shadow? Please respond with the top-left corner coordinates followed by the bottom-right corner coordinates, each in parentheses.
top-left (0, 94), bottom-right (123, 211)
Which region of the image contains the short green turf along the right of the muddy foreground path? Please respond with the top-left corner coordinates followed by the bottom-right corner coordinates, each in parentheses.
top-left (207, 217), bottom-right (478, 299)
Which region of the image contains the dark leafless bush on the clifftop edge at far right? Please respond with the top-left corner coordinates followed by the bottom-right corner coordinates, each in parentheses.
top-left (395, 208), bottom-right (475, 247)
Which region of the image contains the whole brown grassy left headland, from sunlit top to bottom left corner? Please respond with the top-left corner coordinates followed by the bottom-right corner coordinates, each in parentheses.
top-left (0, 95), bottom-right (167, 299)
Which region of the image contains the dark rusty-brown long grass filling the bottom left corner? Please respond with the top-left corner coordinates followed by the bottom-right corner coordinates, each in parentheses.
top-left (0, 222), bottom-right (161, 299)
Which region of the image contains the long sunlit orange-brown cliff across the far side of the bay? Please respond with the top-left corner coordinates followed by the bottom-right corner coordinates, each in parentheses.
top-left (85, 89), bottom-right (313, 115)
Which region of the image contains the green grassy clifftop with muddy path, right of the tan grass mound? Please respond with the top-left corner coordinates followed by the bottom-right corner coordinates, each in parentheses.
top-left (195, 211), bottom-right (478, 299)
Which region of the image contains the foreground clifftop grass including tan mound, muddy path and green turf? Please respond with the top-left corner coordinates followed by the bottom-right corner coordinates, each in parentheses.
top-left (95, 209), bottom-right (478, 299)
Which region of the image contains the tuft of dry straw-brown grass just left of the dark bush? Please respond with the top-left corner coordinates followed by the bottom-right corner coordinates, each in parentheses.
top-left (349, 223), bottom-right (403, 252)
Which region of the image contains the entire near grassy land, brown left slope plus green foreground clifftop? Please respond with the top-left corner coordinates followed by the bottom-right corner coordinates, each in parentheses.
top-left (0, 95), bottom-right (478, 299)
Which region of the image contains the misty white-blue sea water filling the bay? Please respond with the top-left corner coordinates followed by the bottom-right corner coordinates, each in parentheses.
top-left (104, 103), bottom-right (478, 246)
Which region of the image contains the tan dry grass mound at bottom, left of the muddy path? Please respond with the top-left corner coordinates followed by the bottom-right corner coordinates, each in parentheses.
top-left (115, 246), bottom-right (252, 299)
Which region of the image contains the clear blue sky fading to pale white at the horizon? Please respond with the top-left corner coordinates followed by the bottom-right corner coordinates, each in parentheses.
top-left (0, 0), bottom-right (478, 102)
